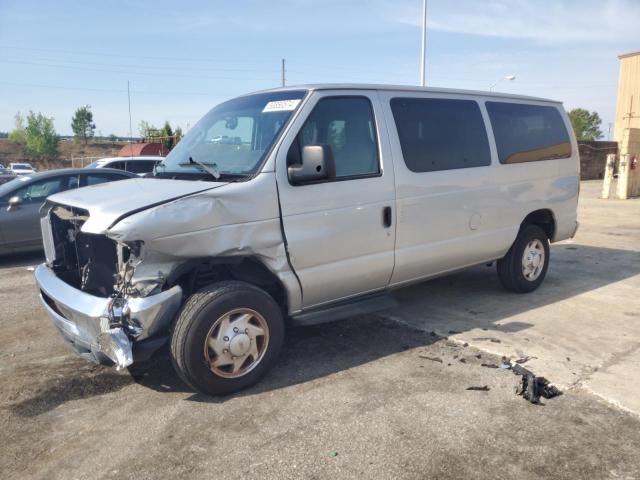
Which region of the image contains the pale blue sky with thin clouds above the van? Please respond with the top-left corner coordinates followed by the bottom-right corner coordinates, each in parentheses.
top-left (0, 0), bottom-right (640, 137)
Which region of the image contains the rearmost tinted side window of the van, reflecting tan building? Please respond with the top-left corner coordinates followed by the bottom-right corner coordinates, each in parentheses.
top-left (487, 102), bottom-right (571, 163)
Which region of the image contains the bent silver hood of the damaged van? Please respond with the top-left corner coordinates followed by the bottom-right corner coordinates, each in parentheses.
top-left (48, 178), bottom-right (226, 233)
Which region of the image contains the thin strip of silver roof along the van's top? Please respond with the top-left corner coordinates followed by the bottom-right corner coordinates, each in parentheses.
top-left (250, 83), bottom-right (562, 103)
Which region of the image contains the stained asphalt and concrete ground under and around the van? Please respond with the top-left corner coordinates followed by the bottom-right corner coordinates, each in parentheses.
top-left (0, 182), bottom-right (640, 480)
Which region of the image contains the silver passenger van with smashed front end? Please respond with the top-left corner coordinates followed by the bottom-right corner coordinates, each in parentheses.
top-left (35, 85), bottom-right (579, 395)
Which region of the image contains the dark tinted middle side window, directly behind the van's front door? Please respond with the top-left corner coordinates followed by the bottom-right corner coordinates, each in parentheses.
top-left (391, 98), bottom-right (491, 172)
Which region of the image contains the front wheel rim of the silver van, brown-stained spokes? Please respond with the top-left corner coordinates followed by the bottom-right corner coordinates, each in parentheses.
top-left (204, 308), bottom-right (269, 378)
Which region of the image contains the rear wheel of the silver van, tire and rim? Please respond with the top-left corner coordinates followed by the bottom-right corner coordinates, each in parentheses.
top-left (498, 225), bottom-right (549, 293)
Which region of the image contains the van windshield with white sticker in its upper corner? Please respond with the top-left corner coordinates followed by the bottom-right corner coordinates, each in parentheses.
top-left (155, 90), bottom-right (306, 179)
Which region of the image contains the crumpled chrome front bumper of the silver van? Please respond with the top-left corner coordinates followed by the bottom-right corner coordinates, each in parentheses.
top-left (35, 264), bottom-right (182, 369)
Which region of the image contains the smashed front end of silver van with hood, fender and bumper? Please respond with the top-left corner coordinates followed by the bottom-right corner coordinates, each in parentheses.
top-left (35, 173), bottom-right (293, 369)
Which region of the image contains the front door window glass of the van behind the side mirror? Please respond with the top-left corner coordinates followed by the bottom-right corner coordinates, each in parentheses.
top-left (298, 97), bottom-right (380, 177)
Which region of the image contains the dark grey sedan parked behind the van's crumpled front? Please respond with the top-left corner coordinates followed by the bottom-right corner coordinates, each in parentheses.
top-left (0, 168), bottom-right (136, 255)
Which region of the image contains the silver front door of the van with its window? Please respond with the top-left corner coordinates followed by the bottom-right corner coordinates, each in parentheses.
top-left (276, 90), bottom-right (395, 308)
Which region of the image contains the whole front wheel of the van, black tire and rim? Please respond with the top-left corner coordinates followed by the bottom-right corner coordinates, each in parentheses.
top-left (171, 281), bottom-right (284, 395)
